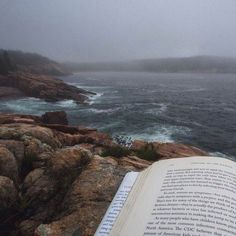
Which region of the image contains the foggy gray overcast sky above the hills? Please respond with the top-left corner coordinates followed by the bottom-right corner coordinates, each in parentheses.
top-left (0, 0), bottom-right (236, 62)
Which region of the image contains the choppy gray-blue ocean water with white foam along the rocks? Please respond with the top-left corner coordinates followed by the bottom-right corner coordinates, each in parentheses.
top-left (0, 72), bottom-right (236, 157)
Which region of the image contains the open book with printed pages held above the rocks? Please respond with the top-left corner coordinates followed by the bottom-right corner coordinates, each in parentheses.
top-left (95, 157), bottom-right (236, 236)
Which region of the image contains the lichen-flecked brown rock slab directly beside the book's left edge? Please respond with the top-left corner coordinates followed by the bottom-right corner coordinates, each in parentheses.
top-left (35, 156), bottom-right (146, 236)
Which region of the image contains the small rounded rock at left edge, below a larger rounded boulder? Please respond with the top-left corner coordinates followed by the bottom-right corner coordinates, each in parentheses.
top-left (0, 176), bottom-right (17, 211)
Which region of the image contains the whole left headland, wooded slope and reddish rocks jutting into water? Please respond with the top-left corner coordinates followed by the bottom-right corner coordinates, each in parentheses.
top-left (0, 49), bottom-right (94, 102)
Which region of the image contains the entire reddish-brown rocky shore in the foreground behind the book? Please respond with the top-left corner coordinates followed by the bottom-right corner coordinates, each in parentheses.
top-left (0, 112), bottom-right (207, 236)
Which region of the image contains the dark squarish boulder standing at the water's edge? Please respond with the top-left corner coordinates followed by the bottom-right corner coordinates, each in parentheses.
top-left (42, 111), bottom-right (68, 125)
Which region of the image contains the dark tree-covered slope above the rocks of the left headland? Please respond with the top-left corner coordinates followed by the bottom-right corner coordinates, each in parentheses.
top-left (0, 50), bottom-right (68, 75)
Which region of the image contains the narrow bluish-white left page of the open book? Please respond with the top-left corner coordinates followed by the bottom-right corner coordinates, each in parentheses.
top-left (95, 172), bottom-right (139, 236)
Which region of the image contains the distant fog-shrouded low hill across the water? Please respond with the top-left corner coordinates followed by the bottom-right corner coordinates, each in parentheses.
top-left (64, 56), bottom-right (236, 73)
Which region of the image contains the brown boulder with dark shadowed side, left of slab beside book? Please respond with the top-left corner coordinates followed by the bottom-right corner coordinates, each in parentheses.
top-left (18, 147), bottom-right (92, 232)
